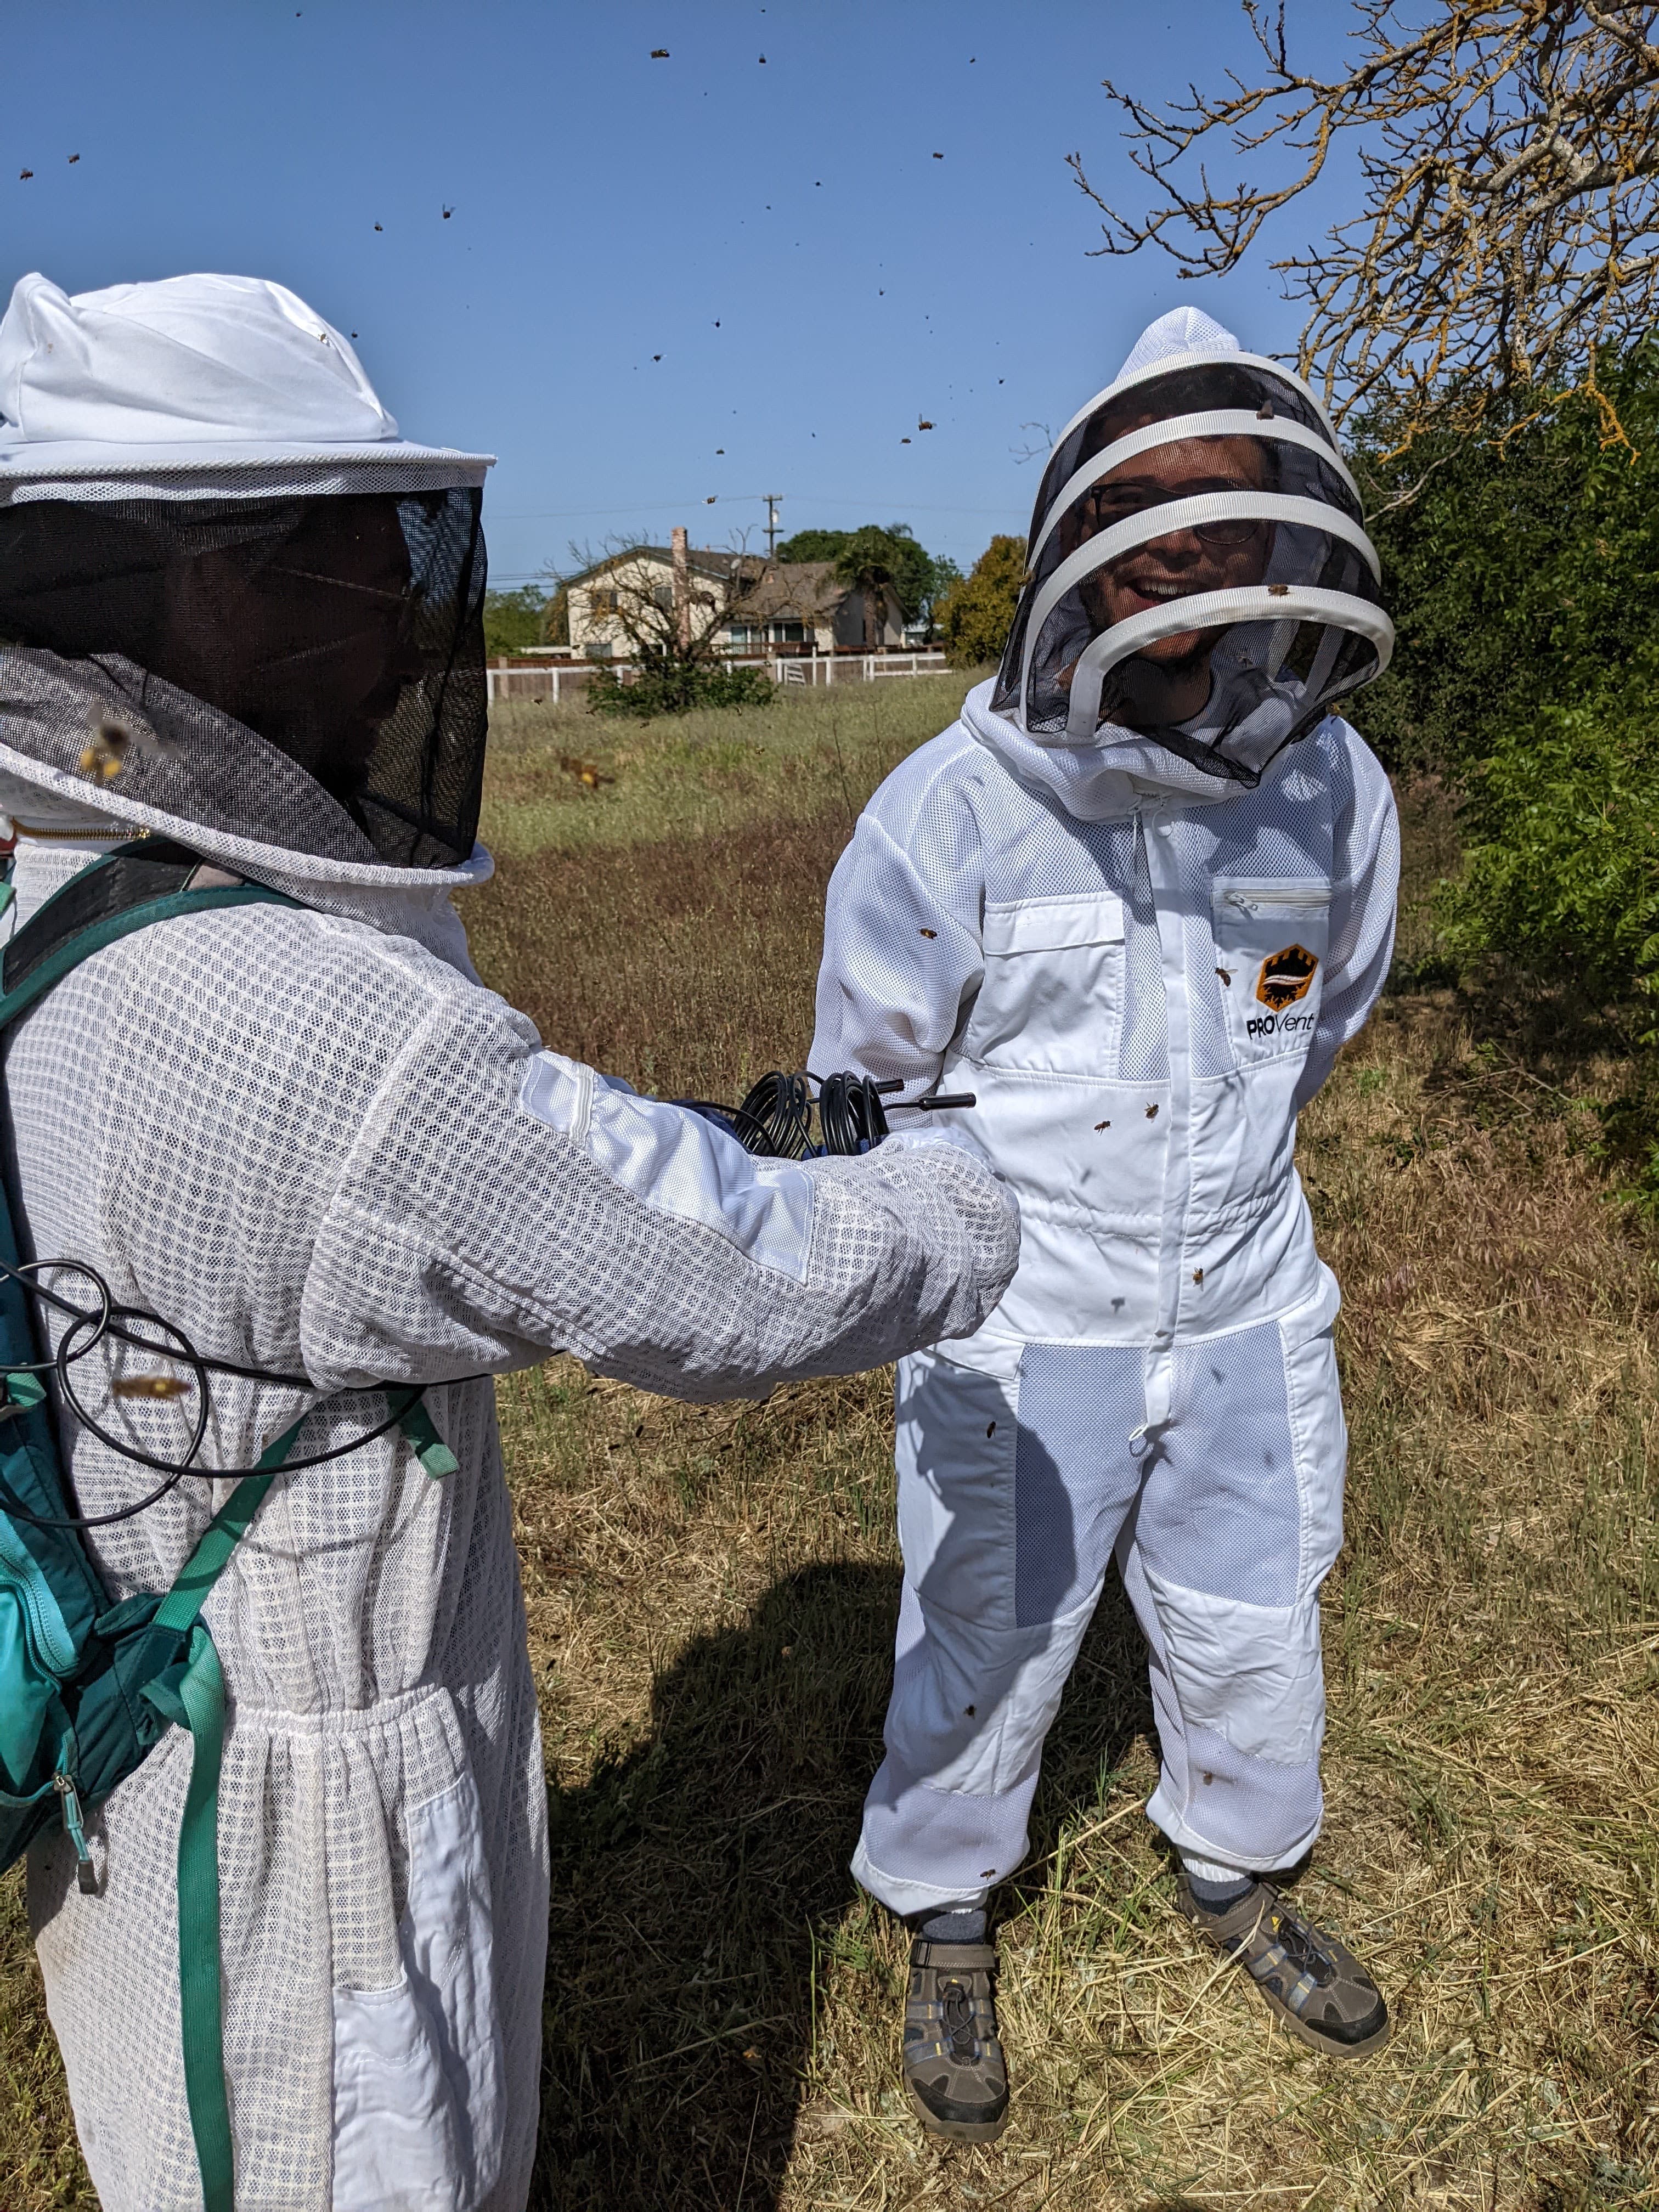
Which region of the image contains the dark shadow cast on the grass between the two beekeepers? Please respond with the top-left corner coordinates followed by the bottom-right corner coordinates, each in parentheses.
top-left (531, 1564), bottom-right (1150, 2212)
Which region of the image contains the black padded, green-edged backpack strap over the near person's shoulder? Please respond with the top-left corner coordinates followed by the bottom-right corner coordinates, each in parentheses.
top-left (0, 838), bottom-right (296, 1031)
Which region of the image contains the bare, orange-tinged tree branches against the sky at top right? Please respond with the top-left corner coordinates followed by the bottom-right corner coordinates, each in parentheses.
top-left (1068, 0), bottom-right (1659, 444)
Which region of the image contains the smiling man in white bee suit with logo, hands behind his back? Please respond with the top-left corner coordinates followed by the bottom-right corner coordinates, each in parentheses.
top-left (812, 309), bottom-right (1398, 2137)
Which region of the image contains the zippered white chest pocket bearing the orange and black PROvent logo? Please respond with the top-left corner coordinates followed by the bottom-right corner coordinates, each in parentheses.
top-left (1215, 883), bottom-right (1331, 1068)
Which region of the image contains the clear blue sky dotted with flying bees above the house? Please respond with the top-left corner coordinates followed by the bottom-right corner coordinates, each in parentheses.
top-left (0, 0), bottom-right (1345, 582)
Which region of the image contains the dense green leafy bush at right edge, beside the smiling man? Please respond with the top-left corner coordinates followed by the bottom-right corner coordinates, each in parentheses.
top-left (1356, 341), bottom-right (1659, 1215)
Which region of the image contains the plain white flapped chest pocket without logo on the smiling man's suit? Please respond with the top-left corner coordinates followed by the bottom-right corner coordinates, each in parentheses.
top-left (962, 891), bottom-right (1124, 1075)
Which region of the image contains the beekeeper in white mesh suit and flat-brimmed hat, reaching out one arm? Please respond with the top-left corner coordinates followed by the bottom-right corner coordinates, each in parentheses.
top-left (0, 276), bottom-right (1018, 2212)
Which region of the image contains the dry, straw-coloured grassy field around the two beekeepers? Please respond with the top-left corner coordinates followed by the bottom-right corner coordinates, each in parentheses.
top-left (0, 679), bottom-right (1659, 2212)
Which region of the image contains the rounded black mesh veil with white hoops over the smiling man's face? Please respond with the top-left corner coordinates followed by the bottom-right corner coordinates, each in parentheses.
top-left (993, 354), bottom-right (1393, 783)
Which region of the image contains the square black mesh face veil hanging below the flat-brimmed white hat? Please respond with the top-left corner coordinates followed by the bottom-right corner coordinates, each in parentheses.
top-left (0, 489), bottom-right (489, 867)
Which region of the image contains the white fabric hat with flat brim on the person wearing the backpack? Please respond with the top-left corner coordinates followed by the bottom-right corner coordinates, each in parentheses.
top-left (0, 274), bottom-right (493, 504)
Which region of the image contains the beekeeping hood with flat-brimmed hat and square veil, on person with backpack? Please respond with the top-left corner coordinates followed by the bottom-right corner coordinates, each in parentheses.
top-left (0, 276), bottom-right (489, 887)
